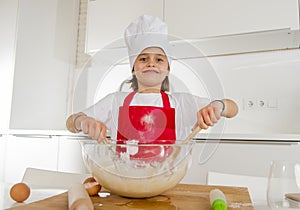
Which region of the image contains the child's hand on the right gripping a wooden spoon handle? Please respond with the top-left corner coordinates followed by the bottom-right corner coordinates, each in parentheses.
top-left (195, 101), bottom-right (223, 129)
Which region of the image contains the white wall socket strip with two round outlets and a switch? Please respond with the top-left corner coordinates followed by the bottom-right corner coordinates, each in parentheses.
top-left (243, 98), bottom-right (278, 110)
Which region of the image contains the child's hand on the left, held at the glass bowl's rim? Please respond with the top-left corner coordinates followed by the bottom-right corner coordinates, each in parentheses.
top-left (80, 116), bottom-right (107, 143)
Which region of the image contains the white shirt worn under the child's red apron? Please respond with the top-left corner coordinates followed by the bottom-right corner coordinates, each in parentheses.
top-left (83, 92), bottom-right (210, 140)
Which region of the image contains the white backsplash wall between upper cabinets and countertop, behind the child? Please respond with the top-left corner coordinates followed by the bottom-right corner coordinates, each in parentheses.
top-left (74, 49), bottom-right (300, 139)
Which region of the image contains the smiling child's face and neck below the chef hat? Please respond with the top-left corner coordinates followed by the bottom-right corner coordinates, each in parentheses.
top-left (132, 47), bottom-right (169, 92)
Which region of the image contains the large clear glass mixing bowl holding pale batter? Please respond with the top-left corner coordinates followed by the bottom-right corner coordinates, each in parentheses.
top-left (81, 140), bottom-right (194, 198)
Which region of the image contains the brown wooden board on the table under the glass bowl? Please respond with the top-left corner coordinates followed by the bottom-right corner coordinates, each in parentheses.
top-left (10, 184), bottom-right (254, 210)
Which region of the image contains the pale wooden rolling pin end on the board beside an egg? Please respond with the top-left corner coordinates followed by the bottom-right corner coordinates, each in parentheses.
top-left (68, 183), bottom-right (94, 210)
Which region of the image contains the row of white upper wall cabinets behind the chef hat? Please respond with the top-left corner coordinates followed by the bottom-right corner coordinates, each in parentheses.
top-left (81, 0), bottom-right (300, 59)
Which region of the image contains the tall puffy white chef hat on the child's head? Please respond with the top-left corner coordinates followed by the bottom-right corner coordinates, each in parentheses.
top-left (124, 15), bottom-right (171, 69)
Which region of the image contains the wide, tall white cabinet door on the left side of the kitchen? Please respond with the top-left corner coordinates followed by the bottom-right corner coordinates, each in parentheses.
top-left (10, 0), bottom-right (78, 130)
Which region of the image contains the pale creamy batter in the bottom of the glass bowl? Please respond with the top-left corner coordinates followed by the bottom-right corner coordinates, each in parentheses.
top-left (91, 157), bottom-right (190, 198)
